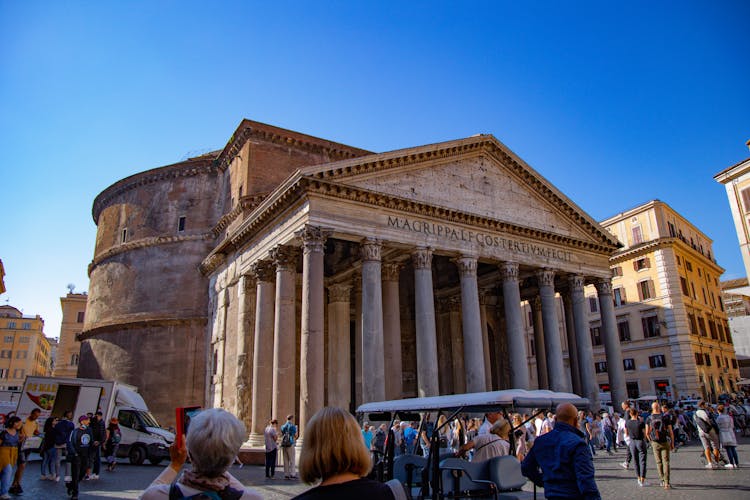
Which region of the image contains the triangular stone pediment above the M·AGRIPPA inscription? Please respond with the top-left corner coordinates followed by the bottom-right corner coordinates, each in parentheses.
top-left (302, 136), bottom-right (617, 246)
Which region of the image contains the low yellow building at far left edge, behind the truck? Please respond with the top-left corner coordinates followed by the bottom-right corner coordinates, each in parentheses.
top-left (0, 306), bottom-right (50, 391)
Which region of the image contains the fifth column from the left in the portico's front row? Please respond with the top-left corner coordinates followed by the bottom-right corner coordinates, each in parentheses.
top-left (499, 262), bottom-right (541, 390)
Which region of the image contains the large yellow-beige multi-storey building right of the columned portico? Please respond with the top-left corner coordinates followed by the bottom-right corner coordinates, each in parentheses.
top-left (587, 200), bottom-right (739, 399)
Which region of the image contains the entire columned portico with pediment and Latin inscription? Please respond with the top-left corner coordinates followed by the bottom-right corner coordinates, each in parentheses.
top-left (202, 131), bottom-right (626, 442)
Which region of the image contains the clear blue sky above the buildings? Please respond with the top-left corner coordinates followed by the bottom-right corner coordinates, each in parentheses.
top-left (0, 0), bottom-right (750, 336)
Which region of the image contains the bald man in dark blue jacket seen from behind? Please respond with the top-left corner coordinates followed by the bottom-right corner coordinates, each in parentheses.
top-left (521, 403), bottom-right (601, 500)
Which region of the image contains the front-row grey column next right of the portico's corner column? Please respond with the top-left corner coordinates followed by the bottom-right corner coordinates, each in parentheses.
top-left (362, 238), bottom-right (385, 403)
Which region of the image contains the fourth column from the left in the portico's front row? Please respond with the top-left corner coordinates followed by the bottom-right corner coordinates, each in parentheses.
top-left (455, 255), bottom-right (487, 392)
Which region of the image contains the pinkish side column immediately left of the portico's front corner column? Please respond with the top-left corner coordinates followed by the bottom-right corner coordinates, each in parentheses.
top-left (270, 245), bottom-right (298, 422)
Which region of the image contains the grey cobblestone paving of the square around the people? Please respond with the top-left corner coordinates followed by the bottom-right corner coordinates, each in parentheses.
top-left (14, 438), bottom-right (750, 500)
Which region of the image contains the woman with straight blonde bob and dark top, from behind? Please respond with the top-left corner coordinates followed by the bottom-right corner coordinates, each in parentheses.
top-left (294, 407), bottom-right (405, 500)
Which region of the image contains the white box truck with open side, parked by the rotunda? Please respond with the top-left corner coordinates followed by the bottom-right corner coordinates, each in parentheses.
top-left (16, 376), bottom-right (174, 465)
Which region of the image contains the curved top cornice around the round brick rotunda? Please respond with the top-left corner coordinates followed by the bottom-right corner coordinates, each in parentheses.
top-left (91, 156), bottom-right (217, 225)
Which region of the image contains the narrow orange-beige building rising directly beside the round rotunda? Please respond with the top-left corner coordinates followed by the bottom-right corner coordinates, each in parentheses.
top-left (54, 292), bottom-right (88, 377)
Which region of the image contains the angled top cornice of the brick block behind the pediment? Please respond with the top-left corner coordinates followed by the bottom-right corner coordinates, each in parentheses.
top-left (215, 120), bottom-right (372, 171)
